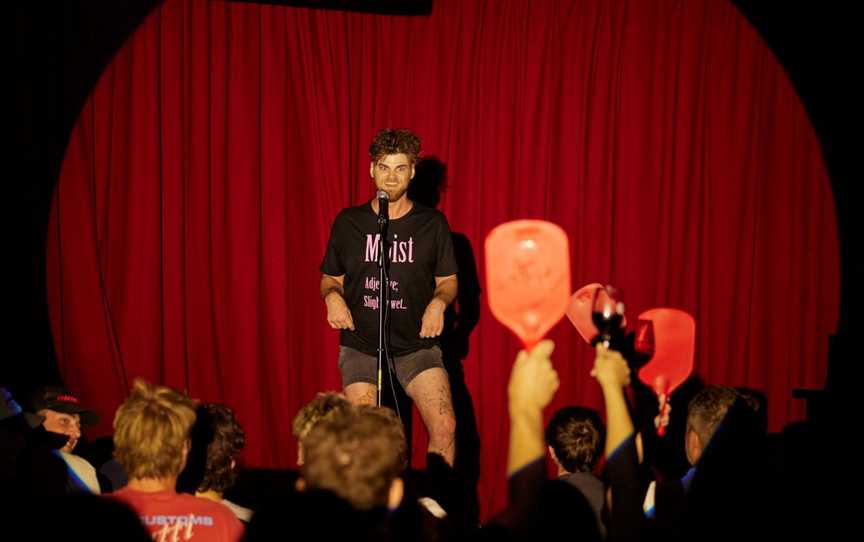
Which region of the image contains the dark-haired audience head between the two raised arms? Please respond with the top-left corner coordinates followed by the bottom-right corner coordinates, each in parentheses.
top-left (546, 406), bottom-right (603, 472)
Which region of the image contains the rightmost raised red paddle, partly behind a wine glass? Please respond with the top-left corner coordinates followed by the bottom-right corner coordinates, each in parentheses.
top-left (634, 308), bottom-right (696, 437)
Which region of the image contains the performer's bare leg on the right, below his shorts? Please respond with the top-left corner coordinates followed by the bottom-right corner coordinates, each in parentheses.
top-left (405, 367), bottom-right (456, 466)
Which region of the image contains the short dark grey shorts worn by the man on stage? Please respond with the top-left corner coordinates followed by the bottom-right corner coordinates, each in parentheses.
top-left (339, 346), bottom-right (444, 389)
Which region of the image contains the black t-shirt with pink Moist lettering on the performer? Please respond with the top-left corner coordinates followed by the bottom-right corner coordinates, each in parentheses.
top-left (321, 203), bottom-right (457, 356)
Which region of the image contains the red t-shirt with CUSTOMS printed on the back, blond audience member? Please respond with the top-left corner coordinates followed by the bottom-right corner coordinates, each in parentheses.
top-left (110, 487), bottom-right (243, 542)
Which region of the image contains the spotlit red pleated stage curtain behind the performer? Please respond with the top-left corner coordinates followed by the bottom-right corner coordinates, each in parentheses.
top-left (48, 0), bottom-right (839, 515)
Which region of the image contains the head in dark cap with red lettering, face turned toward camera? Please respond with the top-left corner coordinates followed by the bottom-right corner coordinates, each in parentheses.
top-left (30, 386), bottom-right (99, 452)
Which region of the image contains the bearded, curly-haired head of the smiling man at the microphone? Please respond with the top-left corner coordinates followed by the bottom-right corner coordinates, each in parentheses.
top-left (369, 129), bottom-right (420, 202)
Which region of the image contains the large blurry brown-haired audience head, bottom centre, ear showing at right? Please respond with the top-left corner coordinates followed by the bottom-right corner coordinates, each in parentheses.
top-left (301, 407), bottom-right (407, 510)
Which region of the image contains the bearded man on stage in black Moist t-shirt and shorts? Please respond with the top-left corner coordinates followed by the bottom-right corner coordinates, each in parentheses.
top-left (321, 130), bottom-right (457, 465)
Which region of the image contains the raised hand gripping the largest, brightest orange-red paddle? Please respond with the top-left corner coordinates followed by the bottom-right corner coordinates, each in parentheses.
top-left (507, 340), bottom-right (559, 416)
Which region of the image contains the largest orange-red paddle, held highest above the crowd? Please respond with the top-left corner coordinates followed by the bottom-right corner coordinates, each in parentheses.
top-left (486, 220), bottom-right (570, 350)
